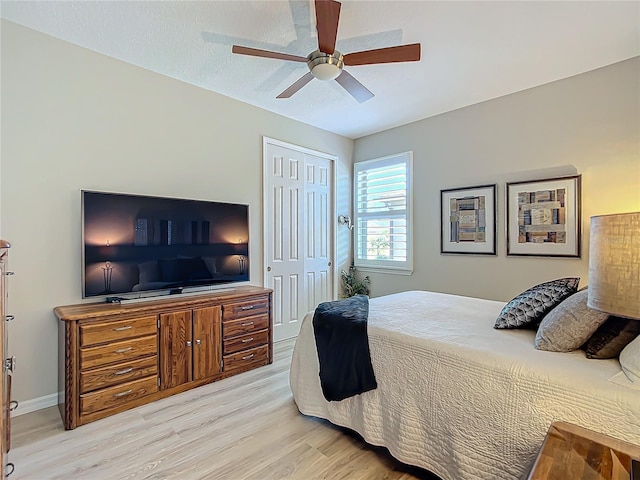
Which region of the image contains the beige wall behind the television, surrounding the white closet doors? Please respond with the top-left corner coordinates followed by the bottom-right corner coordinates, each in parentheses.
top-left (1, 21), bottom-right (353, 401)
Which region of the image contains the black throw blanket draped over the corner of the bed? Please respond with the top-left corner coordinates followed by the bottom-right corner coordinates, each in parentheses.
top-left (313, 295), bottom-right (378, 401)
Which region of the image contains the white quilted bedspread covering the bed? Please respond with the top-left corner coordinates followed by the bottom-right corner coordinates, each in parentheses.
top-left (290, 291), bottom-right (640, 480)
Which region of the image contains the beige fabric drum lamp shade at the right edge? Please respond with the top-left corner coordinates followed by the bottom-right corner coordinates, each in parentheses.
top-left (587, 212), bottom-right (640, 319)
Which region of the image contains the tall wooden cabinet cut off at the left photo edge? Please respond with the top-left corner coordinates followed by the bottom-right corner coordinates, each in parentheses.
top-left (0, 240), bottom-right (17, 478)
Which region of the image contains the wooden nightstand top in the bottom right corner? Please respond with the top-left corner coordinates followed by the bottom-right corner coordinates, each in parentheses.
top-left (528, 422), bottom-right (640, 480)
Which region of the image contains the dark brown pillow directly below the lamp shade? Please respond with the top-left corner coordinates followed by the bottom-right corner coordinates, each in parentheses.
top-left (582, 315), bottom-right (640, 359)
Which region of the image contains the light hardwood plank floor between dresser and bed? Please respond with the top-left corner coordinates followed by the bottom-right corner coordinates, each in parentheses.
top-left (9, 341), bottom-right (433, 480)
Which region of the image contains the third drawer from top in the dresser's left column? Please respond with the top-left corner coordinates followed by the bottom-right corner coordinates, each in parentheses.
top-left (80, 355), bottom-right (158, 393)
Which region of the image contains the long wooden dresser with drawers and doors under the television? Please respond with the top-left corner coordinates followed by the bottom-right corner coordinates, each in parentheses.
top-left (54, 287), bottom-right (273, 429)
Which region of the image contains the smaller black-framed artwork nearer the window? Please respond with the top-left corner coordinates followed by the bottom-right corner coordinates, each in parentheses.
top-left (440, 184), bottom-right (497, 255)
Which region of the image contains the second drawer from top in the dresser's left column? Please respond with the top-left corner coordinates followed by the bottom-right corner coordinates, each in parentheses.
top-left (80, 335), bottom-right (158, 370)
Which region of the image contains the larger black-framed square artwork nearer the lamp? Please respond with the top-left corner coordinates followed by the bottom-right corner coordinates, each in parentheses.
top-left (506, 175), bottom-right (582, 258)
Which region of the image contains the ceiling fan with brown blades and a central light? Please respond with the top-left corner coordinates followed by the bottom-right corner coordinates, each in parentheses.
top-left (231, 0), bottom-right (420, 103)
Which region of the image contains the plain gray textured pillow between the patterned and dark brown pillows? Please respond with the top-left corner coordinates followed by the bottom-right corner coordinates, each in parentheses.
top-left (535, 289), bottom-right (609, 352)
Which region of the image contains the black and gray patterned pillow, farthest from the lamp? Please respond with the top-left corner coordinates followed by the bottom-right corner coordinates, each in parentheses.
top-left (493, 277), bottom-right (580, 328)
